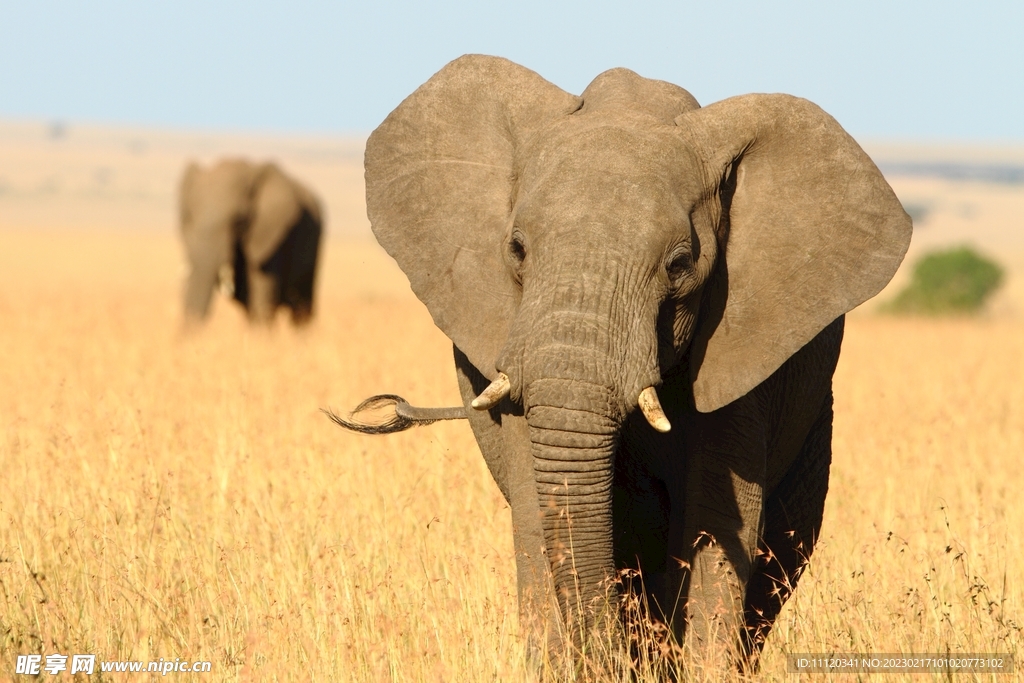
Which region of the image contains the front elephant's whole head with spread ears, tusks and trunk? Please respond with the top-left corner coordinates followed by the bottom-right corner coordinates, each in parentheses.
top-left (366, 55), bottom-right (910, 638)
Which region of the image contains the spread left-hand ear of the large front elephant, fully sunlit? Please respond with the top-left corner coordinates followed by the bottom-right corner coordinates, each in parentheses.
top-left (366, 55), bottom-right (581, 378)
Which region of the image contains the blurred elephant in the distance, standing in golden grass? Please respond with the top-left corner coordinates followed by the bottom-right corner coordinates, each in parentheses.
top-left (179, 159), bottom-right (323, 325)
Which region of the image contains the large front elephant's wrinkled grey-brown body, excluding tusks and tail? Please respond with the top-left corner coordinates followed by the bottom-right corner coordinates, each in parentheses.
top-left (366, 55), bottom-right (910, 663)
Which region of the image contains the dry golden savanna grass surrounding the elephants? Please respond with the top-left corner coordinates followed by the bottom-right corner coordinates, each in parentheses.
top-left (0, 231), bottom-right (1024, 682)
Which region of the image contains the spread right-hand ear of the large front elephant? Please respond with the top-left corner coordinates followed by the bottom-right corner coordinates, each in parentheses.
top-left (676, 94), bottom-right (911, 412)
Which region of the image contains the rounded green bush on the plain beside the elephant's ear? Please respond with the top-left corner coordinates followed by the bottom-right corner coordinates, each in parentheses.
top-left (885, 247), bottom-right (1002, 315)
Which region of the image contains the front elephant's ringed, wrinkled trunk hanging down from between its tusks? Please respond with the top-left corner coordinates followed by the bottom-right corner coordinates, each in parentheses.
top-left (523, 342), bottom-right (656, 642)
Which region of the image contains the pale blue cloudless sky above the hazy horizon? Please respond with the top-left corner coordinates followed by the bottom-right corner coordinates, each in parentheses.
top-left (0, 0), bottom-right (1024, 142)
